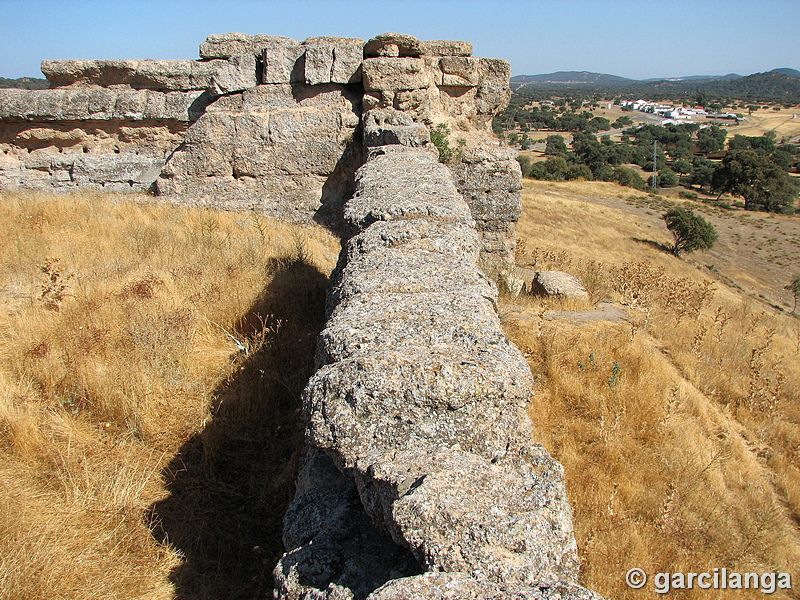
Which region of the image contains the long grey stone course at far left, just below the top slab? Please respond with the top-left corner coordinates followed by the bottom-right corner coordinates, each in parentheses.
top-left (0, 86), bottom-right (205, 121)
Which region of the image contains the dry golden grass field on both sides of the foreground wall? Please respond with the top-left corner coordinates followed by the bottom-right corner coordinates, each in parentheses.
top-left (0, 181), bottom-right (800, 600)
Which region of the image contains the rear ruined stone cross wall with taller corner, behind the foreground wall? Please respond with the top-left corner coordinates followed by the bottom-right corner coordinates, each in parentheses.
top-left (0, 33), bottom-right (521, 274)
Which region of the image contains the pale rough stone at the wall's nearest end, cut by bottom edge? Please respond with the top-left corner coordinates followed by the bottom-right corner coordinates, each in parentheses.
top-left (367, 572), bottom-right (602, 600)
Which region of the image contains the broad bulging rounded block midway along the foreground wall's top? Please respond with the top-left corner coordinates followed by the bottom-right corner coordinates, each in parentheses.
top-left (304, 345), bottom-right (531, 464)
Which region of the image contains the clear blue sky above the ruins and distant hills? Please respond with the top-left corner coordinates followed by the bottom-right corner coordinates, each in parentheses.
top-left (0, 0), bottom-right (800, 79)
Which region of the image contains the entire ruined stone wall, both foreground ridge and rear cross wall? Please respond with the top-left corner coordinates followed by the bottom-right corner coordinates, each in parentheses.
top-left (0, 34), bottom-right (599, 600)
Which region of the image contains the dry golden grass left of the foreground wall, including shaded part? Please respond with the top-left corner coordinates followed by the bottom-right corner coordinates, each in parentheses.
top-left (0, 194), bottom-right (339, 600)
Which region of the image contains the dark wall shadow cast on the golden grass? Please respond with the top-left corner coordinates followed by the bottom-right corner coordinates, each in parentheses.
top-left (150, 258), bottom-right (328, 600)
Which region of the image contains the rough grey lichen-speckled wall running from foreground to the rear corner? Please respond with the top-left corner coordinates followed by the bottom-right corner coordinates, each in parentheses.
top-left (275, 123), bottom-right (599, 600)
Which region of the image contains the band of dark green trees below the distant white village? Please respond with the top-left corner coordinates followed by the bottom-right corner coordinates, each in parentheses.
top-left (518, 123), bottom-right (800, 213)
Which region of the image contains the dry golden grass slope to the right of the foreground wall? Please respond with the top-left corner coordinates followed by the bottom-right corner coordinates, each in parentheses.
top-left (505, 183), bottom-right (800, 599)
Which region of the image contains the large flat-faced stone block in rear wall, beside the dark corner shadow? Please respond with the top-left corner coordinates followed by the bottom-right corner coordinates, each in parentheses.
top-left (157, 83), bottom-right (363, 222)
